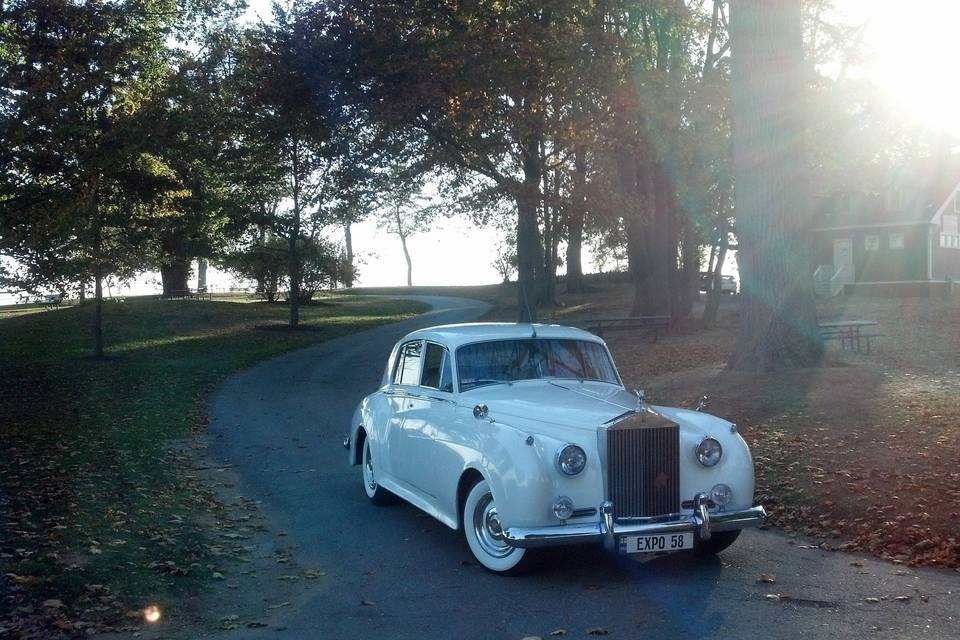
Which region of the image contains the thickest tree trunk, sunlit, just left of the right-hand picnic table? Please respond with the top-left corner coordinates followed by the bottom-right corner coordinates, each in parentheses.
top-left (728, 0), bottom-right (823, 372)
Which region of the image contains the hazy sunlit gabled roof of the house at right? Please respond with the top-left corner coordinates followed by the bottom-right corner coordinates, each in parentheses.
top-left (815, 156), bottom-right (960, 228)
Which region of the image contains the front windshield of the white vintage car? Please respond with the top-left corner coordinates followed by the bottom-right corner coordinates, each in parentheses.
top-left (457, 338), bottom-right (620, 391)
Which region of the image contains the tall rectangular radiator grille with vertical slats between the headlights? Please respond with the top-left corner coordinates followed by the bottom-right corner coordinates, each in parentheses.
top-left (607, 424), bottom-right (680, 518)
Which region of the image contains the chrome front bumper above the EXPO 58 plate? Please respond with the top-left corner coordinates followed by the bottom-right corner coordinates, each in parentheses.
top-left (503, 494), bottom-right (767, 550)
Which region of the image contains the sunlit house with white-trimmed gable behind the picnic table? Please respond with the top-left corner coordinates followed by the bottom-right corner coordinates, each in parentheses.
top-left (813, 158), bottom-right (960, 295)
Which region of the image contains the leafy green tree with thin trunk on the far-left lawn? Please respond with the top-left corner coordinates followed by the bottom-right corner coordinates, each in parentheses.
top-left (0, 0), bottom-right (181, 357)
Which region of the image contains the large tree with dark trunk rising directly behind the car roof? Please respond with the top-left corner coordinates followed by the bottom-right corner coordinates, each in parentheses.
top-left (332, 0), bottom-right (608, 321)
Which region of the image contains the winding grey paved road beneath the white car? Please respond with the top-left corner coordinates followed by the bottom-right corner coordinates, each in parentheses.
top-left (202, 297), bottom-right (960, 640)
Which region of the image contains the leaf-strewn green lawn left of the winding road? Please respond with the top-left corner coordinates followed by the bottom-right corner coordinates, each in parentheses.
top-left (0, 295), bottom-right (424, 637)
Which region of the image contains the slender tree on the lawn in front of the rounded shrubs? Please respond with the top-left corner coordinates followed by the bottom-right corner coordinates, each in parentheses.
top-left (238, 2), bottom-right (341, 327)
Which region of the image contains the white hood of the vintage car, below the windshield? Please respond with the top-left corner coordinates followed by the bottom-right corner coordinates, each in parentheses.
top-left (460, 380), bottom-right (639, 431)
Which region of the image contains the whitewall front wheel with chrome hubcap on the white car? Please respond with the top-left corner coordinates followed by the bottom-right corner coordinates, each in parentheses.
top-left (463, 480), bottom-right (534, 575)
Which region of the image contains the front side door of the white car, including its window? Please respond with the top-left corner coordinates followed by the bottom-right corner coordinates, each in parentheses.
top-left (401, 342), bottom-right (460, 502)
